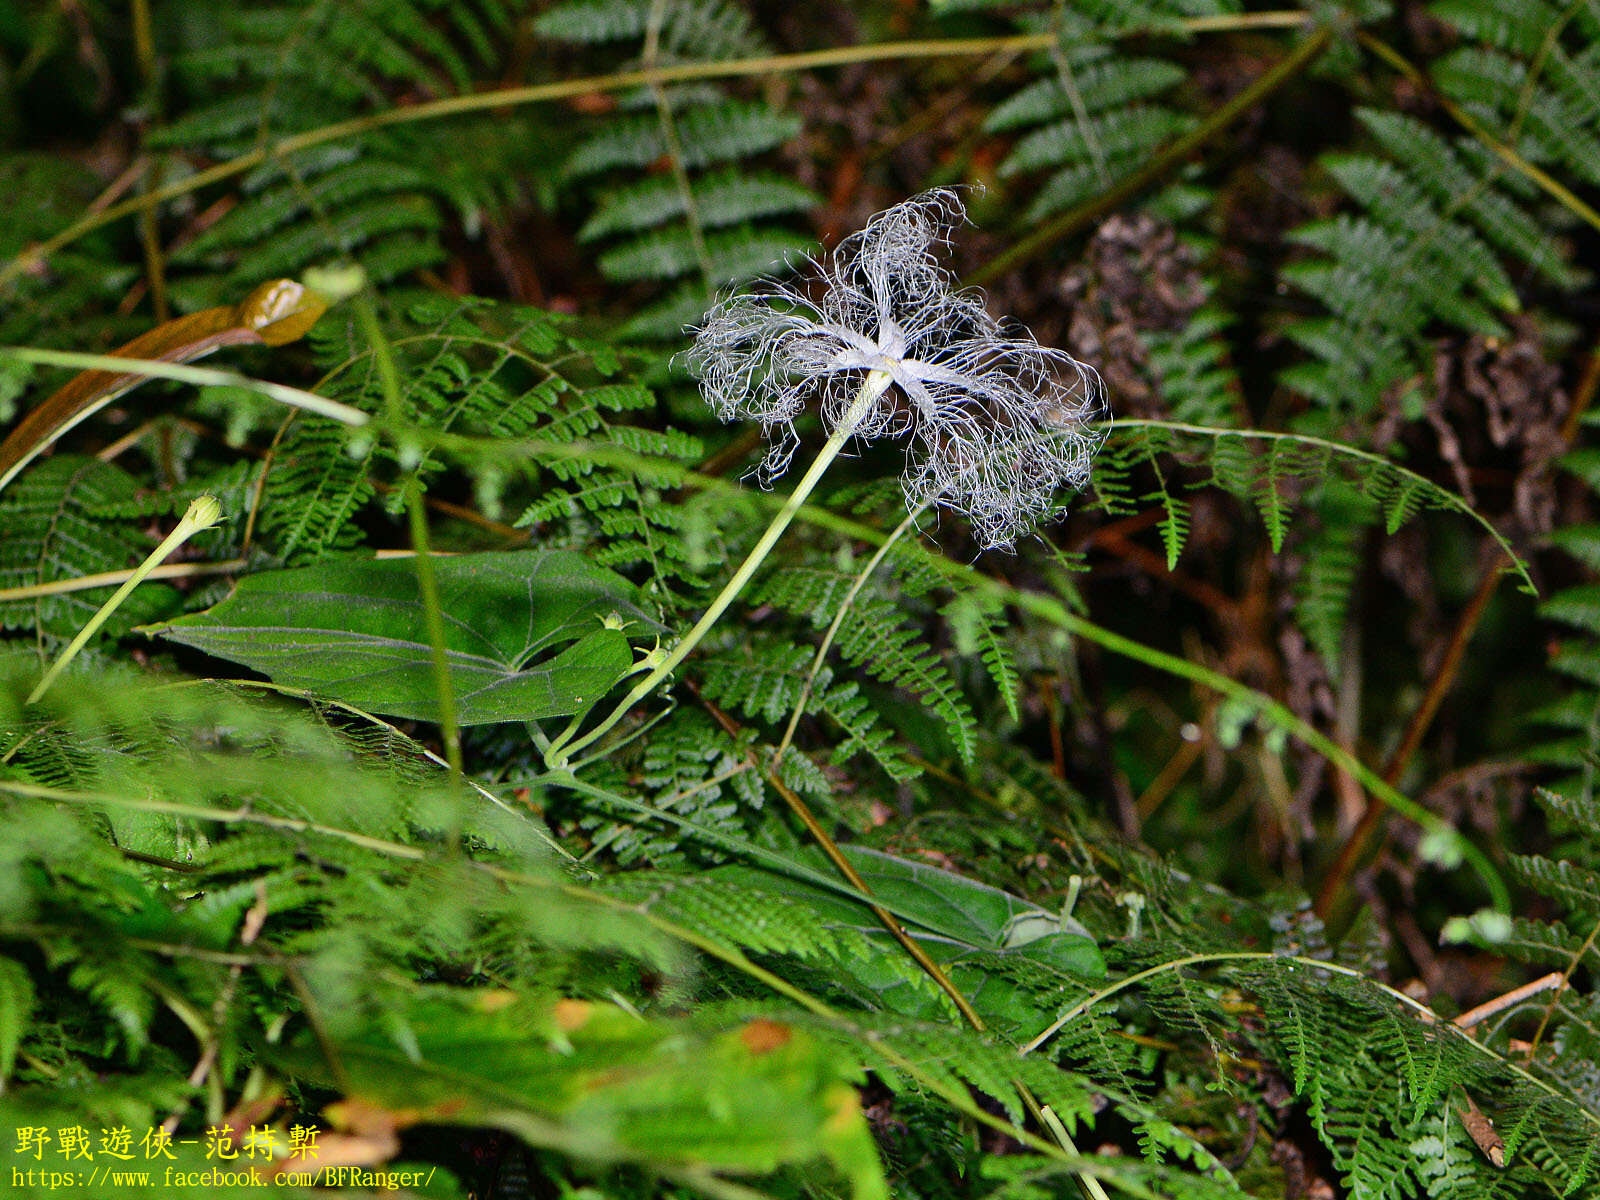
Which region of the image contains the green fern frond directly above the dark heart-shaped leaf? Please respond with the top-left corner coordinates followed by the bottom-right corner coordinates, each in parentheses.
top-left (248, 296), bottom-right (701, 598)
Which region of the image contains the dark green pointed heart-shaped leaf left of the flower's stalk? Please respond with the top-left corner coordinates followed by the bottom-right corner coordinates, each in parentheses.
top-left (154, 550), bottom-right (656, 725)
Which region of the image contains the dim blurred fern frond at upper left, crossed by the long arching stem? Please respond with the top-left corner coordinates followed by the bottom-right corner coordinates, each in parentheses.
top-left (150, 0), bottom-right (510, 307)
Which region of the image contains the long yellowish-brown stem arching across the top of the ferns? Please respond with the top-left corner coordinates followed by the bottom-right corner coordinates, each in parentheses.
top-left (0, 10), bottom-right (1307, 286)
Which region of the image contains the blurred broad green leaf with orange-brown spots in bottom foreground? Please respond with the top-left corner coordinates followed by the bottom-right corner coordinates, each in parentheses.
top-left (282, 989), bottom-right (886, 1200)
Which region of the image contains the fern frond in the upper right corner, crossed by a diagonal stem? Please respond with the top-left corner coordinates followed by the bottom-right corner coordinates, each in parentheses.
top-left (1282, 0), bottom-right (1600, 421)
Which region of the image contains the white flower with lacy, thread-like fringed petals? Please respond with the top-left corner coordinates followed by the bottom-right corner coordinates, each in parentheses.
top-left (690, 187), bottom-right (1104, 549)
